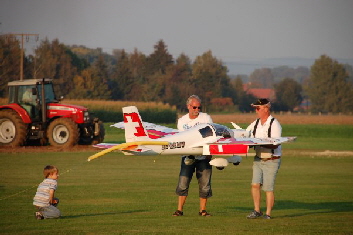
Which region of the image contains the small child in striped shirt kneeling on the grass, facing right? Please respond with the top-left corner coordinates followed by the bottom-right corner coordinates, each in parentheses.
top-left (33, 165), bottom-right (61, 220)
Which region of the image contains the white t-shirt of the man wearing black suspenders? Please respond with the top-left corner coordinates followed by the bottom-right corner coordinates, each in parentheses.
top-left (246, 115), bottom-right (282, 158)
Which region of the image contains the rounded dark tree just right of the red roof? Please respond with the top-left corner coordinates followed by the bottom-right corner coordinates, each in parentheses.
top-left (275, 78), bottom-right (303, 111)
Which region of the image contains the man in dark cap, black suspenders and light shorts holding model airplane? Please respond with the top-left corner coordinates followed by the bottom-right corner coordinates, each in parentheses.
top-left (246, 99), bottom-right (282, 219)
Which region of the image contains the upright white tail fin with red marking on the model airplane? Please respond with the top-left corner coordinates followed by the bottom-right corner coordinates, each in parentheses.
top-left (123, 106), bottom-right (151, 143)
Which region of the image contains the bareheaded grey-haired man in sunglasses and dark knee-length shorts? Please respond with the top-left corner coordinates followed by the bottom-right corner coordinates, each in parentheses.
top-left (173, 95), bottom-right (212, 216)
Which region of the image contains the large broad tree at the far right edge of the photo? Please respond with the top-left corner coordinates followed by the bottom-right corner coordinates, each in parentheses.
top-left (307, 55), bottom-right (353, 112)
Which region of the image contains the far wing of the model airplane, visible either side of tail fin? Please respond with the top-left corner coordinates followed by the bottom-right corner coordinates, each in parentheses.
top-left (111, 122), bottom-right (179, 139)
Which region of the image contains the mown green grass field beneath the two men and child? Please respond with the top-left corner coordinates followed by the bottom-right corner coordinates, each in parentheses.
top-left (0, 125), bottom-right (353, 234)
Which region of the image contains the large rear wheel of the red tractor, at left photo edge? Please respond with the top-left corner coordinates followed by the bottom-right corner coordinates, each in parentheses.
top-left (0, 109), bottom-right (27, 146)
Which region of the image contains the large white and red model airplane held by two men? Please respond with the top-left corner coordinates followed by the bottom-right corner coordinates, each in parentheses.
top-left (88, 106), bottom-right (296, 169)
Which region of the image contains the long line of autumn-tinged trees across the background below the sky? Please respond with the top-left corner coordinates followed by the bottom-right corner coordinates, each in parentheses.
top-left (0, 37), bottom-right (353, 112)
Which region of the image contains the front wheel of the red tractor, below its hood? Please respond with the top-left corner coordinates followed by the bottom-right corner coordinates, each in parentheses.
top-left (47, 118), bottom-right (80, 147)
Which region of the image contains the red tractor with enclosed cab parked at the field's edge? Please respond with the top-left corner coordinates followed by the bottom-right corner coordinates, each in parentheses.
top-left (0, 78), bottom-right (105, 147)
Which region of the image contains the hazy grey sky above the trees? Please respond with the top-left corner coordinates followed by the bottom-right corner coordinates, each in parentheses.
top-left (0, 0), bottom-right (353, 66)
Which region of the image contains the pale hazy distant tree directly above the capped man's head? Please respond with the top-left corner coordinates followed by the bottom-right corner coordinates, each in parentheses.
top-left (249, 68), bottom-right (274, 89)
